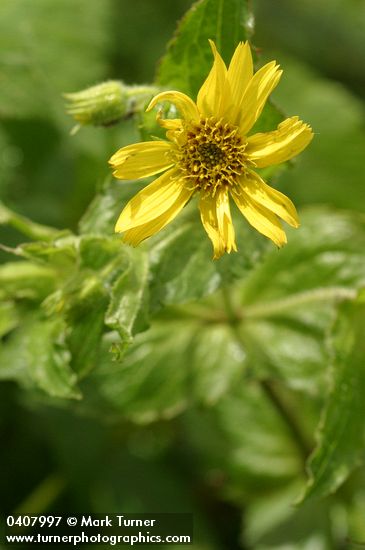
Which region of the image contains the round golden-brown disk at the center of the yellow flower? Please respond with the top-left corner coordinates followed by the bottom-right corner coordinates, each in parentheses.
top-left (176, 117), bottom-right (246, 195)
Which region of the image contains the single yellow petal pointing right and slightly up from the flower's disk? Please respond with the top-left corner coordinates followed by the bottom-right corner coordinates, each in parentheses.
top-left (245, 116), bottom-right (313, 168)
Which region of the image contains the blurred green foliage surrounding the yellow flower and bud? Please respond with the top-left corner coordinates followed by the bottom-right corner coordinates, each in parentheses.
top-left (0, 0), bottom-right (365, 550)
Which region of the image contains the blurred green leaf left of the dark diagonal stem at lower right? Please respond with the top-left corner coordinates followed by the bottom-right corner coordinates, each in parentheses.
top-left (184, 377), bottom-right (302, 504)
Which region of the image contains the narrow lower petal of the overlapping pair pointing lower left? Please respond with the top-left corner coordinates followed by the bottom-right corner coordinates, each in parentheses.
top-left (123, 187), bottom-right (191, 246)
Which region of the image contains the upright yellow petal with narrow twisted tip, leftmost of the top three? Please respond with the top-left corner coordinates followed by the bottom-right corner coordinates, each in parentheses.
top-left (197, 40), bottom-right (231, 118)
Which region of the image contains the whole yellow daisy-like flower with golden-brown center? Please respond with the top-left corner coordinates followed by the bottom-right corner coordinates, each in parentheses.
top-left (109, 41), bottom-right (313, 259)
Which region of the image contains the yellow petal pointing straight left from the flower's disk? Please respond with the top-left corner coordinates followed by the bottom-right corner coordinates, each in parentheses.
top-left (109, 141), bottom-right (174, 179)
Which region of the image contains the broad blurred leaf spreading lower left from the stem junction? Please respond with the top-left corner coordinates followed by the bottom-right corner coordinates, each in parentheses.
top-left (85, 315), bottom-right (244, 423)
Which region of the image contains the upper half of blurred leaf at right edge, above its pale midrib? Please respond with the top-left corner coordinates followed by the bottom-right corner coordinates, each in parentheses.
top-left (243, 207), bottom-right (365, 306)
